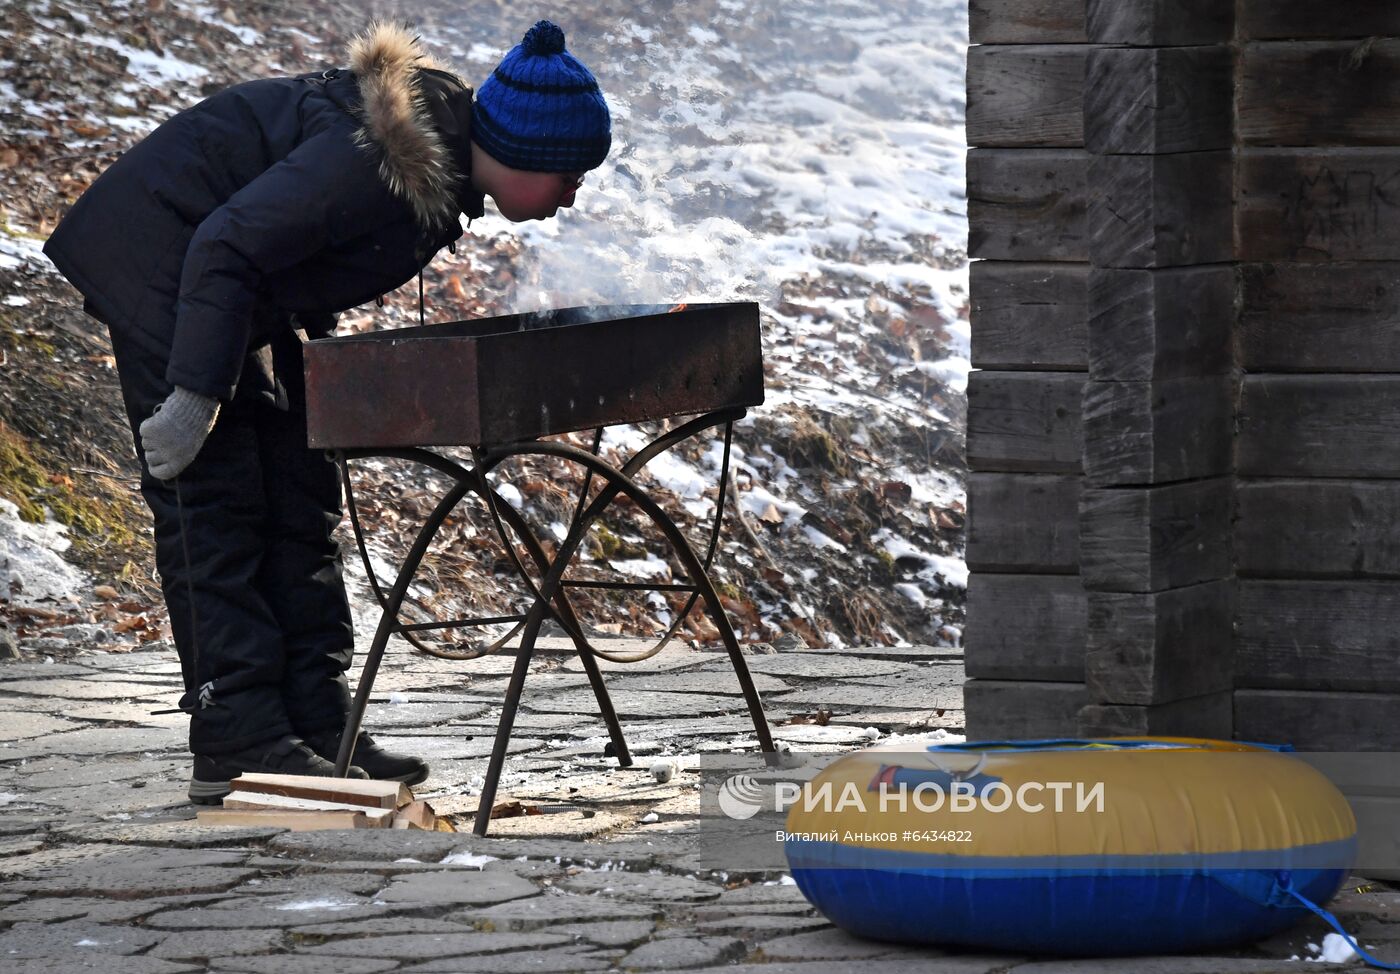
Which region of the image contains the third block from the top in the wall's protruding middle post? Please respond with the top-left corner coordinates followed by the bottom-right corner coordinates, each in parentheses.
top-left (1086, 151), bottom-right (1233, 267)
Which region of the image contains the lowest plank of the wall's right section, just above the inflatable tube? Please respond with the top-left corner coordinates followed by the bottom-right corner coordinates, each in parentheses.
top-left (1235, 690), bottom-right (1400, 751)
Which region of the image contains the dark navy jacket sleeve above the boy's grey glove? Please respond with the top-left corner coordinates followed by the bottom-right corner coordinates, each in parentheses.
top-left (165, 129), bottom-right (406, 400)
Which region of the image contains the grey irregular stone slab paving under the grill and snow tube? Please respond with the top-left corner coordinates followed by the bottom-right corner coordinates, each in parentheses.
top-left (0, 644), bottom-right (1400, 974)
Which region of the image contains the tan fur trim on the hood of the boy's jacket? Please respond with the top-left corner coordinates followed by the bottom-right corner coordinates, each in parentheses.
top-left (349, 22), bottom-right (466, 227)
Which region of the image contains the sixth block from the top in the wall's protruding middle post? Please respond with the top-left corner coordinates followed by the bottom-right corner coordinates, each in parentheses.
top-left (1079, 477), bottom-right (1232, 592)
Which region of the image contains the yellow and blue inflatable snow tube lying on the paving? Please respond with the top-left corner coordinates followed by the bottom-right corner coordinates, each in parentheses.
top-left (783, 737), bottom-right (1357, 956)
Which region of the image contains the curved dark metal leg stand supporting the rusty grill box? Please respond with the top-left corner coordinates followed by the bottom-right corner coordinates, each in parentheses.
top-left (332, 409), bottom-right (777, 835)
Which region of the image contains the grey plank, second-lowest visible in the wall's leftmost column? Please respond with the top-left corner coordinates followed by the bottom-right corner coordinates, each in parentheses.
top-left (963, 571), bottom-right (1088, 683)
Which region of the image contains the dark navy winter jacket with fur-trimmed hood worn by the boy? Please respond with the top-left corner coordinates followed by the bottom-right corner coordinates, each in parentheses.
top-left (43, 27), bottom-right (482, 400)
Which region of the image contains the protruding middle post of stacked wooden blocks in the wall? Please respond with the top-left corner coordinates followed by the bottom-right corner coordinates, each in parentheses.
top-left (1078, 0), bottom-right (1235, 737)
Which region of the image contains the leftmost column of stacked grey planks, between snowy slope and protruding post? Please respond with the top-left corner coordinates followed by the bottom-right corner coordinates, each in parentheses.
top-left (965, 0), bottom-right (1092, 737)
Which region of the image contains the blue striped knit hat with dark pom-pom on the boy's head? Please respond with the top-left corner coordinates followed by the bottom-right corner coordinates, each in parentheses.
top-left (472, 21), bottom-right (612, 172)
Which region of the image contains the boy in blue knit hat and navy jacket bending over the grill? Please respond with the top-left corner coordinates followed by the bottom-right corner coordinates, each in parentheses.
top-left (43, 21), bottom-right (610, 803)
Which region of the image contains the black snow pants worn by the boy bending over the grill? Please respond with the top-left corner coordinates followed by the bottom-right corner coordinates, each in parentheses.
top-left (112, 327), bottom-right (354, 754)
